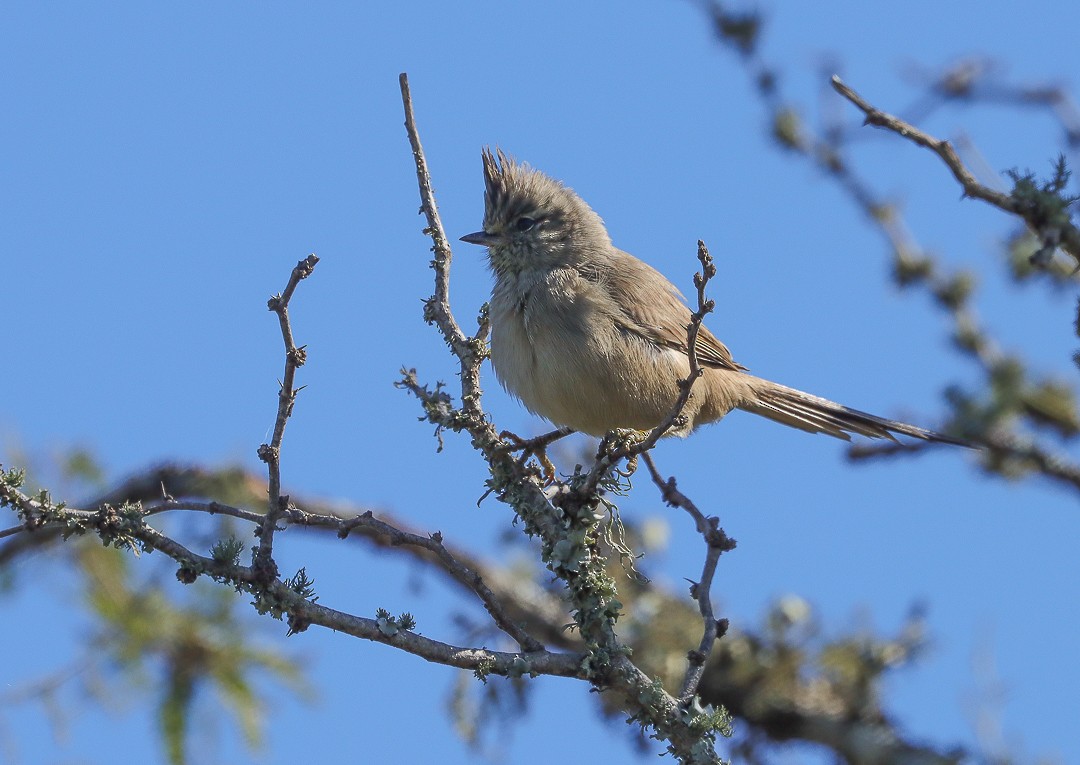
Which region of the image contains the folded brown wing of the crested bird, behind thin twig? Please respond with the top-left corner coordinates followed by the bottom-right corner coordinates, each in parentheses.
top-left (604, 250), bottom-right (746, 372)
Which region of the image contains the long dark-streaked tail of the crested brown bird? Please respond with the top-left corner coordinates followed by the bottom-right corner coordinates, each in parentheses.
top-left (738, 378), bottom-right (971, 446)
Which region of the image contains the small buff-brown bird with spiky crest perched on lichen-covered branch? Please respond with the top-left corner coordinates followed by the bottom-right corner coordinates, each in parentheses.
top-left (461, 148), bottom-right (968, 445)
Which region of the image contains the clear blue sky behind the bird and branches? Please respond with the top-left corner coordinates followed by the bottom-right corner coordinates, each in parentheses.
top-left (0, 0), bottom-right (1080, 764)
